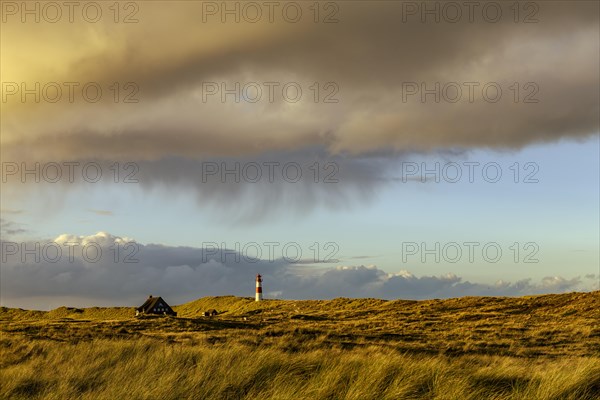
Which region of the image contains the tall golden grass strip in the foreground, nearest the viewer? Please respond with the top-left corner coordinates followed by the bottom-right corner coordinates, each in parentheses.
top-left (0, 339), bottom-right (600, 400)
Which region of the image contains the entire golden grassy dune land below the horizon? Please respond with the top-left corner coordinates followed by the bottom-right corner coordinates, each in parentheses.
top-left (0, 292), bottom-right (600, 400)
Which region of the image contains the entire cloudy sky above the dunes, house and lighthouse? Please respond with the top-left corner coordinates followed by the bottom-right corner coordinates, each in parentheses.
top-left (0, 1), bottom-right (600, 309)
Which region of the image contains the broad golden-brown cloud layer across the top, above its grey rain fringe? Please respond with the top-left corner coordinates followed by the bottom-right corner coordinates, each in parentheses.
top-left (3, 1), bottom-right (599, 160)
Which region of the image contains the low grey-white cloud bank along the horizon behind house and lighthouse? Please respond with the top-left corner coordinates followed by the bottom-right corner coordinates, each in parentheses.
top-left (0, 232), bottom-right (594, 309)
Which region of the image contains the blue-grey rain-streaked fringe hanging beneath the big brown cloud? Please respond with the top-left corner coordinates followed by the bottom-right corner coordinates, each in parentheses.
top-left (4, 148), bottom-right (404, 223)
